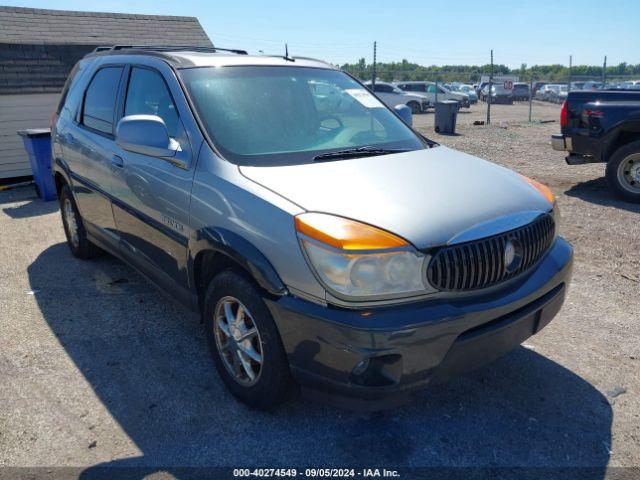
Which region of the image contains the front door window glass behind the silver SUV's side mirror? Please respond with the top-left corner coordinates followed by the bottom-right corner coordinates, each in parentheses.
top-left (124, 67), bottom-right (179, 137)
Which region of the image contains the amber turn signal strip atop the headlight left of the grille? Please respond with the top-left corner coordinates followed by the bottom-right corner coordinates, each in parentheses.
top-left (296, 213), bottom-right (409, 250)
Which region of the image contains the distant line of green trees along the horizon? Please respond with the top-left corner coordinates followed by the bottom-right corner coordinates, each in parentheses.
top-left (341, 58), bottom-right (640, 83)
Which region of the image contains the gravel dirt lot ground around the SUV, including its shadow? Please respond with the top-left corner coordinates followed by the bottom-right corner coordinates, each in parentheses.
top-left (0, 99), bottom-right (640, 477)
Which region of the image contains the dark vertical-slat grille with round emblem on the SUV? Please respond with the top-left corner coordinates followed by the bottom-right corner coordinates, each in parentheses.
top-left (427, 215), bottom-right (555, 292)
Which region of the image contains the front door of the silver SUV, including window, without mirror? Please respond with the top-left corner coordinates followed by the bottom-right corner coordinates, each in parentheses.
top-left (113, 65), bottom-right (195, 291)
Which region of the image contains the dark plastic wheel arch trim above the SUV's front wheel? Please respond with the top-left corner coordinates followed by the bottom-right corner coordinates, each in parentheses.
top-left (189, 227), bottom-right (287, 296)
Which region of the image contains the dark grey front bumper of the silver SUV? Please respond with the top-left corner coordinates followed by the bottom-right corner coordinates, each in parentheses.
top-left (267, 237), bottom-right (573, 408)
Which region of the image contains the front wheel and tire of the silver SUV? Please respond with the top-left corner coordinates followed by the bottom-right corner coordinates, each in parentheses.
top-left (204, 269), bottom-right (293, 410)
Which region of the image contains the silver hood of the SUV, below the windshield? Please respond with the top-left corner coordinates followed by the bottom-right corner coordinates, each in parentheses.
top-left (239, 146), bottom-right (551, 248)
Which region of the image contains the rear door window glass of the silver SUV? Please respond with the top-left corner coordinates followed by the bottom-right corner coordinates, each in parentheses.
top-left (82, 67), bottom-right (122, 134)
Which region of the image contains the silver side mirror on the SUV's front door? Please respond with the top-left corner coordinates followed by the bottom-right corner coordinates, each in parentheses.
top-left (116, 115), bottom-right (180, 160)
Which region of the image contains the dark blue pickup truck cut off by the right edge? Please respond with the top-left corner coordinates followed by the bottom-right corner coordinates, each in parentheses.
top-left (551, 90), bottom-right (640, 203)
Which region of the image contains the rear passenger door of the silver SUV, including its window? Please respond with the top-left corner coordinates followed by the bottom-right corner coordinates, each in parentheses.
top-left (62, 65), bottom-right (124, 248)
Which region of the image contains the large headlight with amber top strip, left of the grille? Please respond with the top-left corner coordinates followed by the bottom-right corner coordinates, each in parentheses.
top-left (296, 213), bottom-right (426, 298)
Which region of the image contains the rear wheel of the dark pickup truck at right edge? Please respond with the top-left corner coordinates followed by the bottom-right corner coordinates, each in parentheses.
top-left (606, 140), bottom-right (640, 203)
